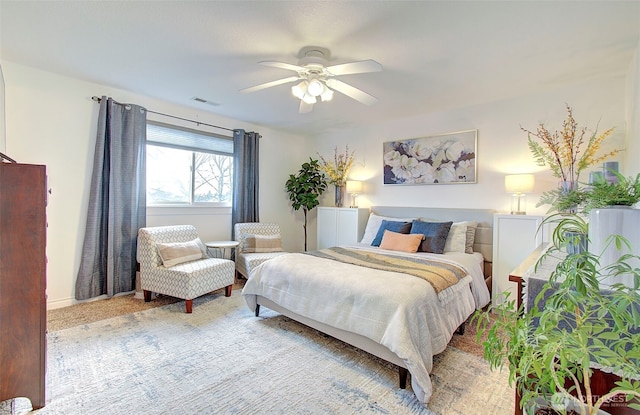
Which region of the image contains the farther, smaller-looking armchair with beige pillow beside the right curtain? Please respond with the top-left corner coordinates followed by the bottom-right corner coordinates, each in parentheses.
top-left (233, 222), bottom-right (286, 278)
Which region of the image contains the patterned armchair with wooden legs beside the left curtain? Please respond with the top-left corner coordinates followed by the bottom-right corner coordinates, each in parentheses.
top-left (137, 225), bottom-right (235, 313)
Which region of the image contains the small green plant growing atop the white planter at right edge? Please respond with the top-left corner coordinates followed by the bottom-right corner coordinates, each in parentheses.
top-left (584, 171), bottom-right (640, 213)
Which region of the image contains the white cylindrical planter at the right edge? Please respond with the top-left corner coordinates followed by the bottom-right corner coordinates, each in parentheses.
top-left (588, 206), bottom-right (640, 286)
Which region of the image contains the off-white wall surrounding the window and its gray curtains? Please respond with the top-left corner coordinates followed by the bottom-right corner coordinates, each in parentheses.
top-left (2, 61), bottom-right (309, 308)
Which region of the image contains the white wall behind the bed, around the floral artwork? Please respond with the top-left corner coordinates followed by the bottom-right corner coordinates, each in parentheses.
top-left (317, 77), bottom-right (639, 218)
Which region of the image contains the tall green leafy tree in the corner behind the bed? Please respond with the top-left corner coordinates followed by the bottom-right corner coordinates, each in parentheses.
top-left (285, 157), bottom-right (327, 251)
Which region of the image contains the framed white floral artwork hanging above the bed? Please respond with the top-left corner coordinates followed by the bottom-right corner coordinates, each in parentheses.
top-left (383, 130), bottom-right (478, 184)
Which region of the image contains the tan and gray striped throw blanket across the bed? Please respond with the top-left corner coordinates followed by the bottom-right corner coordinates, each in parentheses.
top-left (305, 247), bottom-right (467, 294)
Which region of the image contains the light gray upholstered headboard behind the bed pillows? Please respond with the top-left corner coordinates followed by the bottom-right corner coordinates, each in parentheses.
top-left (371, 206), bottom-right (496, 275)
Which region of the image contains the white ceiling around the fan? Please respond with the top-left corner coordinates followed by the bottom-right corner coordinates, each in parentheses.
top-left (0, 0), bottom-right (640, 134)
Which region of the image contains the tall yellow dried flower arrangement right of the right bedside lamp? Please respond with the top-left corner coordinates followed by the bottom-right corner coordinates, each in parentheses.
top-left (520, 105), bottom-right (621, 212)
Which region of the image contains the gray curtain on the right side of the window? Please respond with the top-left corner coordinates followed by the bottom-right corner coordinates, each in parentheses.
top-left (231, 130), bottom-right (260, 238)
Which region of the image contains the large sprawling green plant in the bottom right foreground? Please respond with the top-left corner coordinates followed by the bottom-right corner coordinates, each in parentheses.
top-left (474, 236), bottom-right (640, 415)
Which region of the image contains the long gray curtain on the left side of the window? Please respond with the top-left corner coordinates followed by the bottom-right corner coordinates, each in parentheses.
top-left (76, 96), bottom-right (147, 300)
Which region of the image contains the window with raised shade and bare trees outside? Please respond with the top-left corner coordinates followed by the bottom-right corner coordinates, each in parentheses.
top-left (147, 122), bottom-right (233, 206)
